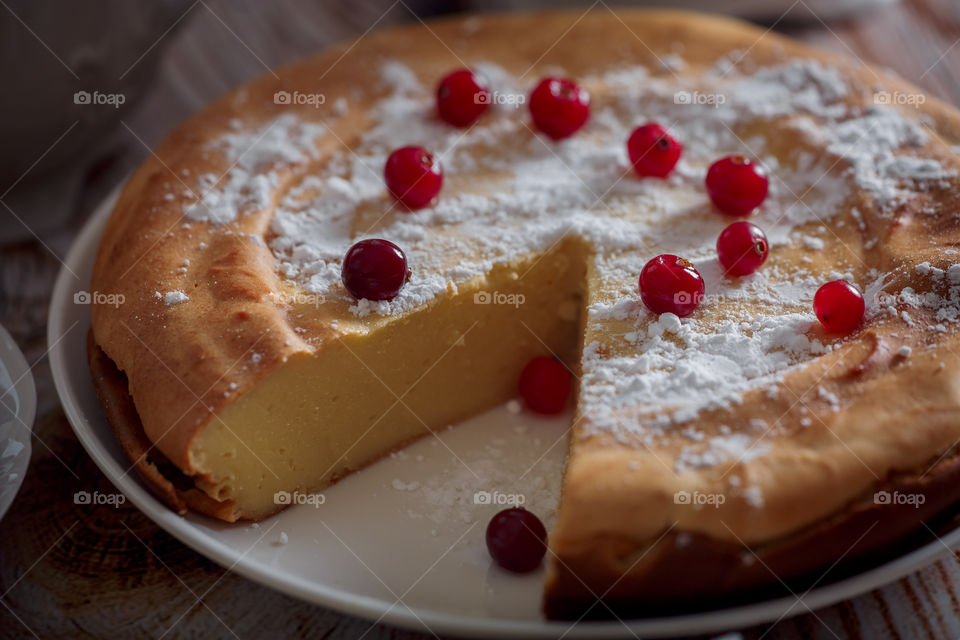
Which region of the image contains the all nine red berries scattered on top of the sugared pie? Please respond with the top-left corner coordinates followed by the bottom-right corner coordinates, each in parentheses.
top-left (343, 69), bottom-right (864, 340)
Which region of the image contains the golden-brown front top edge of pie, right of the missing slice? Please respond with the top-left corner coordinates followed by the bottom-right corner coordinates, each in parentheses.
top-left (548, 328), bottom-right (960, 568)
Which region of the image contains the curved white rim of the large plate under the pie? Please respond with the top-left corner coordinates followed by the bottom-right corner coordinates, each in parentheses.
top-left (47, 188), bottom-right (960, 638)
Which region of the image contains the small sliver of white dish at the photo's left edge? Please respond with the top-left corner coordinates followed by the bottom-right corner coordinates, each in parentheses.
top-left (0, 327), bottom-right (37, 518)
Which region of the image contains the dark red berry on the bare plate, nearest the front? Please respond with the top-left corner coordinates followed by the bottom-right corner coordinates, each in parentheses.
top-left (487, 507), bottom-right (547, 573)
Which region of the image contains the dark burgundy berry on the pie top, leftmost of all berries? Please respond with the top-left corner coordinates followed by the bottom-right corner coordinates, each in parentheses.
top-left (340, 238), bottom-right (407, 300)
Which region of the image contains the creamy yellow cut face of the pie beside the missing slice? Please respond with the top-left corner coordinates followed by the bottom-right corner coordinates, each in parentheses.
top-left (191, 242), bottom-right (586, 517)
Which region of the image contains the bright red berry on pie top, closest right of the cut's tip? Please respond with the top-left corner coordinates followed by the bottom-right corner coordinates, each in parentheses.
top-left (640, 253), bottom-right (704, 318)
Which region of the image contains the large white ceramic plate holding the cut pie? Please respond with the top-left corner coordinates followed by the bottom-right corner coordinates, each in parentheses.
top-left (48, 186), bottom-right (960, 638)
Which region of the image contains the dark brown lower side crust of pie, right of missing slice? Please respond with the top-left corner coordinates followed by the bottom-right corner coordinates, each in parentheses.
top-left (544, 453), bottom-right (960, 620)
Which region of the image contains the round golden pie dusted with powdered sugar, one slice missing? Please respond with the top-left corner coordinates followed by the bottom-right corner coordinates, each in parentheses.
top-left (90, 11), bottom-right (960, 618)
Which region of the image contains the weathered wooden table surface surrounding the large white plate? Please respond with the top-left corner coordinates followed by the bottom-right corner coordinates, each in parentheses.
top-left (0, 0), bottom-right (960, 640)
